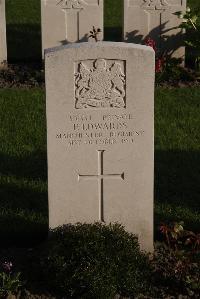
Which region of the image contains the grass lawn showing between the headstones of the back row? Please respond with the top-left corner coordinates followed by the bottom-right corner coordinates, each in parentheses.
top-left (6, 0), bottom-right (200, 62)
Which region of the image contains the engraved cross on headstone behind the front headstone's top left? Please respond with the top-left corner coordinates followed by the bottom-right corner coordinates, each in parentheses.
top-left (57, 0), bottom-right (87, 42)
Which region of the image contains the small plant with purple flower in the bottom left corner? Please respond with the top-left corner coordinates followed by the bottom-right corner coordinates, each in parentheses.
top-left (0, 262), bottom-right (23, 298)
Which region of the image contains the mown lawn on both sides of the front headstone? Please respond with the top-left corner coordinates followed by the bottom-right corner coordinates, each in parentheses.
top-left (0, 87), bottom-right (200, 244)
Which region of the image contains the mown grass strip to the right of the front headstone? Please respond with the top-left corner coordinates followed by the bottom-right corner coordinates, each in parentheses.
top-left (155, 88), bottom-right (200, 230)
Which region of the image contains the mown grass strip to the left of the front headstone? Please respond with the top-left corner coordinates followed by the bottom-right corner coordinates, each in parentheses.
top-left (0, 89), bottom-right (48, 243)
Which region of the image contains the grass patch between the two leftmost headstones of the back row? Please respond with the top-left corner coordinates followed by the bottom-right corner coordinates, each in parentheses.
top-left (6, 0), bottom-right (42, 62)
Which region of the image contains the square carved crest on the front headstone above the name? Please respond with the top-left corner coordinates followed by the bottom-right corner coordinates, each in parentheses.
top-left (75, 59), bottom-right (126, 109)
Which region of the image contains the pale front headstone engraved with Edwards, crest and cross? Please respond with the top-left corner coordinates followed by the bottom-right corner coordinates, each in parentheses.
top-left (45, 42), bottom-right (154, 250)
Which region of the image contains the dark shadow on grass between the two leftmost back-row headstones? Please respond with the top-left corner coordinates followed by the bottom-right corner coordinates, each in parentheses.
top-left (7, 24), bottom-right (42, 62)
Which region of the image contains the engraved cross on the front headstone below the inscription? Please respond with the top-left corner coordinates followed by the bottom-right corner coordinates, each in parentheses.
top-left (78, 150), bottom-right (124, 222)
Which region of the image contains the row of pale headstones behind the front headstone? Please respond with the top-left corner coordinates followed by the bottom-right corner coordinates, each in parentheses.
top-left (0, 0), bottom-right (186, 63)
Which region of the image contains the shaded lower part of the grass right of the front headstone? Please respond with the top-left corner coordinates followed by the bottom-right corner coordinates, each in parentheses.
top-left (155, 151), bottom-right (200, 230)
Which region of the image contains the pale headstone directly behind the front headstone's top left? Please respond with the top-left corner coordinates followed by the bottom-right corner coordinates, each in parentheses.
top-left (41, 0), bottom-right (104, 51)
